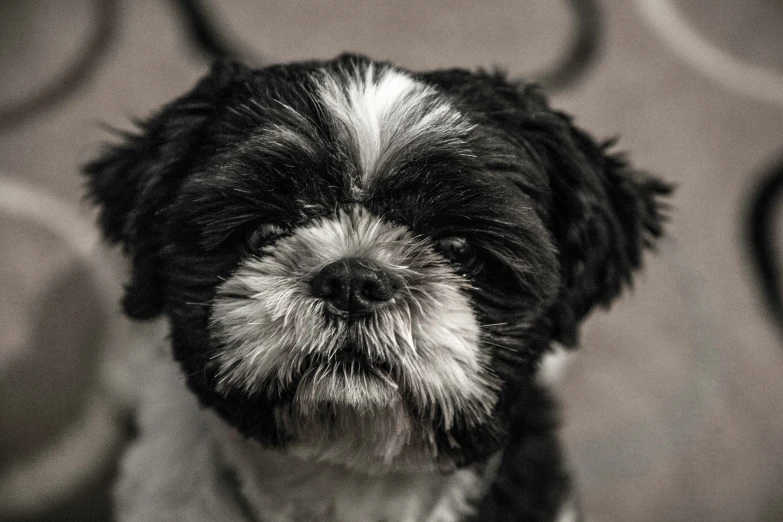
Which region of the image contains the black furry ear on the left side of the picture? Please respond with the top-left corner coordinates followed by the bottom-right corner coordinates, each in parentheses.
top-left (83, 63), bottom-right (249, 319)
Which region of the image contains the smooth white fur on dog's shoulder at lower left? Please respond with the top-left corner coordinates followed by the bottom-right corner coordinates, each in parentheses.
top-left (114, 348), bottom-right (248, 522)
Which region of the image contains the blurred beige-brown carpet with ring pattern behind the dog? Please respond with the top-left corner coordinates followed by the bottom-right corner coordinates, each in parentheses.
top-left (0, 0), bottom-right (783, 521)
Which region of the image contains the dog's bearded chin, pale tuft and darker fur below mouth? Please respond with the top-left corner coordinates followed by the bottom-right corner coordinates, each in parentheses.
top-left (260, 351), bottom-right (453, 473)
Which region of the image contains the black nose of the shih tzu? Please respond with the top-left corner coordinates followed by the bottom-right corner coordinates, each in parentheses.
top-left (311, 258), bottom-right (394, 319)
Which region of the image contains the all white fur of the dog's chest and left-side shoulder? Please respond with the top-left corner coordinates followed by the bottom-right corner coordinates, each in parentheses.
top-left (117, 346), bottom-right (498, 522)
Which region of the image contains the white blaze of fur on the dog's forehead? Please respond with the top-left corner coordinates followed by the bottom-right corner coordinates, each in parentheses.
top-left (317, 64), bottom-right (473, 185)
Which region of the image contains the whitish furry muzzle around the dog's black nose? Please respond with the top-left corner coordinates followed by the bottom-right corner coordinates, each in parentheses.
top-left (211, 207), bottom-right (496, 428)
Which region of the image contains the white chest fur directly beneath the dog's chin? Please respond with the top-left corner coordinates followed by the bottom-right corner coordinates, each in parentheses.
top-left (210, 417), bottom-right (498, 522)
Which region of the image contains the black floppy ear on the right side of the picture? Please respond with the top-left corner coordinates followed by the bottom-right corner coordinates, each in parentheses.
top-left (549, 118), bottom-right (672, 346)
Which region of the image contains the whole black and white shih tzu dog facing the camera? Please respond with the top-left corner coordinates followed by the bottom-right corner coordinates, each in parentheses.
top-left (85, 55), bottom-right (669, 522)
